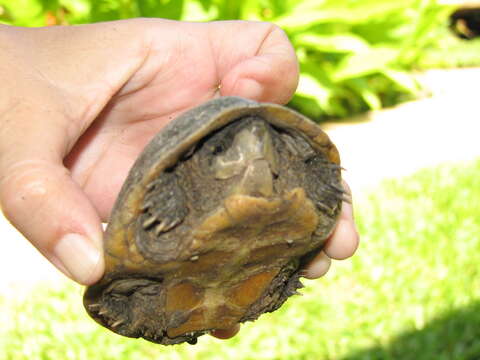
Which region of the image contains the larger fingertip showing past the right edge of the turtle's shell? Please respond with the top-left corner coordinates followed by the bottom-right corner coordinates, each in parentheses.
top-left (323, 182), bottom-right (360, 260)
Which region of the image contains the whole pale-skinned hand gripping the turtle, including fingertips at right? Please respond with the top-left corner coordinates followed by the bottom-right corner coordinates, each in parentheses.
top-left (0, 19), bottom-right (359, 338)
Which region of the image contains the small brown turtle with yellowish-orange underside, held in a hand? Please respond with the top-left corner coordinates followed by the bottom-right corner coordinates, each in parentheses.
top-left (83, 96), bottom-right (347, 345)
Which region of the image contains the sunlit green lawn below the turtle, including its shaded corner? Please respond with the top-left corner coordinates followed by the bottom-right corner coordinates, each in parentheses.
top-left (0, 160), bottom-right (480, 360)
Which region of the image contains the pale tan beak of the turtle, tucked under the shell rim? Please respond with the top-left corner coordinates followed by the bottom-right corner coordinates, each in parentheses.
top-left (215, 120), bottom-right (278, 197)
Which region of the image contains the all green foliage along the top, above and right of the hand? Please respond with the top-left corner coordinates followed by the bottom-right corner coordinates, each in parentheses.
top-left (0, 0), bottom-right (458, 120)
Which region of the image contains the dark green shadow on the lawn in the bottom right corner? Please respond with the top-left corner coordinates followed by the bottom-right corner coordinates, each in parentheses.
top-left (342, 301), bottom-right (480, 360)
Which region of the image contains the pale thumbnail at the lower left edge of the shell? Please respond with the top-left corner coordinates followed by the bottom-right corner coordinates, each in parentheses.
top-left (53, 234), bottom-right (101, 284)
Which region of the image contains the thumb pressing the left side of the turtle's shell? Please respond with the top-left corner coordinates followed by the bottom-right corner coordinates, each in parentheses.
top-left (0, 161), bottom-right (103, 284)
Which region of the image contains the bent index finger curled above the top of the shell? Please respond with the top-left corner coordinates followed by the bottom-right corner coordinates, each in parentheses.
top-left (213, 22), bottom-right (299, 104)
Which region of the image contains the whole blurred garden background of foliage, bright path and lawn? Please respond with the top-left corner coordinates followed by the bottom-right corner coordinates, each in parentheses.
top-left (0, 0), bottom-right (480, 360)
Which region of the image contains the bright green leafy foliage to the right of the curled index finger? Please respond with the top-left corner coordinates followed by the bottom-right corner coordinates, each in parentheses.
top-left (277, 0), bottom-right (446, 118)
